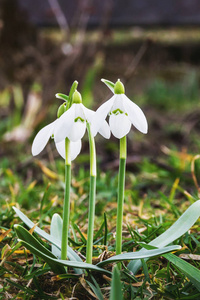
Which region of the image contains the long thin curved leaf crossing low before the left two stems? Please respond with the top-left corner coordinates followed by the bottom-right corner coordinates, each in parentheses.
top-left (19, 240), bottom-right (111, 276)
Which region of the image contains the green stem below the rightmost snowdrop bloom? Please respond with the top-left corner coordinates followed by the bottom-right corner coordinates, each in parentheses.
top-left (116, 136), bottom-right (126, 255)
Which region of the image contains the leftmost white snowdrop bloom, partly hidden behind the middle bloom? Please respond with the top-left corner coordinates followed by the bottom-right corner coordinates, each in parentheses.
top-left (32, 105), bottom-right (81, 160)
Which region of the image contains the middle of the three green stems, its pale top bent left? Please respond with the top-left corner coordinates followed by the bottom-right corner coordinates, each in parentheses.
top-left (86, 123), bottom-right (96, 264)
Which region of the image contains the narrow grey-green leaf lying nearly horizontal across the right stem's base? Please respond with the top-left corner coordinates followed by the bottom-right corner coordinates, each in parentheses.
top-left (97, 245), bottom-right (181, 267)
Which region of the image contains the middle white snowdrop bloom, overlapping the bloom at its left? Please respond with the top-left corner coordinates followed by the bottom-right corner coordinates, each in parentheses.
top-left (54, 91), bottom-right (110, 143)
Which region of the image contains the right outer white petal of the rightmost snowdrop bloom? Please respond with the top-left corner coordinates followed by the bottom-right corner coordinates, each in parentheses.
top-left (123, 95), bottom-right (148, 133)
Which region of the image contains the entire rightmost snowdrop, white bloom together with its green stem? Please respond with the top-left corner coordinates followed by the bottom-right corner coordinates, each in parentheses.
top-left (91, 79), bottom-right (148, 255)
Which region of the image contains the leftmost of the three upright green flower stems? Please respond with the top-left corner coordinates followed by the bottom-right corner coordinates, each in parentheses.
top-left (61, 138), bottom-right (71, 259)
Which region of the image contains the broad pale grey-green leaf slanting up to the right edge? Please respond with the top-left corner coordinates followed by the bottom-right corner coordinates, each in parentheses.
top-left (128, 200), bottom-right (200, 274)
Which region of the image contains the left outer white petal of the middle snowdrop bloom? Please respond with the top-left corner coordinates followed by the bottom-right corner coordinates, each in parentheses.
top-left (54, 104), bottom-right (75, 143)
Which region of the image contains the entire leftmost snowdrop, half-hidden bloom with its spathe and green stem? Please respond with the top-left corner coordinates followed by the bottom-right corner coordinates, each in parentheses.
top-left (32, 81), bottom-right (81, 259)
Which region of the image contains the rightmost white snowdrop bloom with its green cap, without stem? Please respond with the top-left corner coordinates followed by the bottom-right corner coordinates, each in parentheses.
top-left (91, 80), bottom-right (148, 139)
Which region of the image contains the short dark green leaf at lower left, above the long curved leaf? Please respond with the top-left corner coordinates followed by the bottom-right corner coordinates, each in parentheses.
top-left (14, 225), bottom-right (66, 274)
